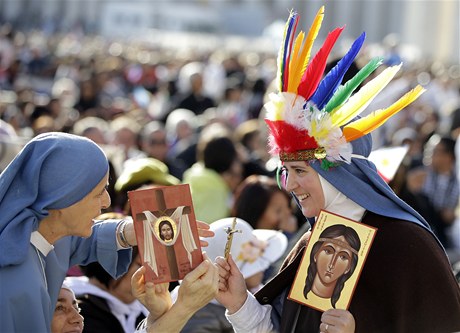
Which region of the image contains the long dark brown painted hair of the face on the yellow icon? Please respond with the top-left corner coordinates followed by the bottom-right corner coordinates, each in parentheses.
top-left (303, 224), bottom-right (361, 308)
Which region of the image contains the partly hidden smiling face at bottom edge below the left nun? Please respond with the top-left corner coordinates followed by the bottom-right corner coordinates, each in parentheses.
top-left (51, 288), bottom-right (83, 333)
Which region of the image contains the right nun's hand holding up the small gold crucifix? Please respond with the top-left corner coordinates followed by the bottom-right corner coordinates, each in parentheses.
top-left (216, 254), bottom-right (247, 314)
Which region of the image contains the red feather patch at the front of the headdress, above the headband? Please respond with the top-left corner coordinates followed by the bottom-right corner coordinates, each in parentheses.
top-left (265, 119), bottom-right (318, 153)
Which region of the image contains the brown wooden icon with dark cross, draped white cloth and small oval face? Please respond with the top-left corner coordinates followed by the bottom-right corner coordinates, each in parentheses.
top-left (128, 184), bottom-right (203, 283)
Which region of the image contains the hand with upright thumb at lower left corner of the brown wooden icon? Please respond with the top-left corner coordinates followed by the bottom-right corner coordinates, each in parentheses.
top-left (131, 267), bottom-right (172, 319)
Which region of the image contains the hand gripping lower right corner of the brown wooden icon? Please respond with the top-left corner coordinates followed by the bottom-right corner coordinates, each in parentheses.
top-left (176, 253), bottom-right (219, 313)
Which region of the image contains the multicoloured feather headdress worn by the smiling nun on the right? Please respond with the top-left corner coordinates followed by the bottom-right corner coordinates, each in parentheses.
top-left (265, 6), bottom-right (424, 168)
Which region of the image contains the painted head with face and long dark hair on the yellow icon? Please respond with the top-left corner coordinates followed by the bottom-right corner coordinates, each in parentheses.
top-left (303, 224), bottom-right (361, 308)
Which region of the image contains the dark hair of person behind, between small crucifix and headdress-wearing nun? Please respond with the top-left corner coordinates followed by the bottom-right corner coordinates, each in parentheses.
top-left (232, 175), bottom-right (291, 229)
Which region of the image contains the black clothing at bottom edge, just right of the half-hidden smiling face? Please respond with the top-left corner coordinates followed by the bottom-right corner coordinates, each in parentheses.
top-left (77, 294), bottom-right (145, 333)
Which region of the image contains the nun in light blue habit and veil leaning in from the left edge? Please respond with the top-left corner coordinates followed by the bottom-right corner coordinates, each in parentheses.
top-left (0, 133), bottom-right (135, 332)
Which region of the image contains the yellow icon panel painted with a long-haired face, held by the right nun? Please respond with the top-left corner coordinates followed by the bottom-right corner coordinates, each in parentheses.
top-left (289, 211), bottom-right (377, 311)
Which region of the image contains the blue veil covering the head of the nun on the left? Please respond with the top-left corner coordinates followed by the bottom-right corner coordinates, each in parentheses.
top-left (0, 132), bottom-right (109, 267)
